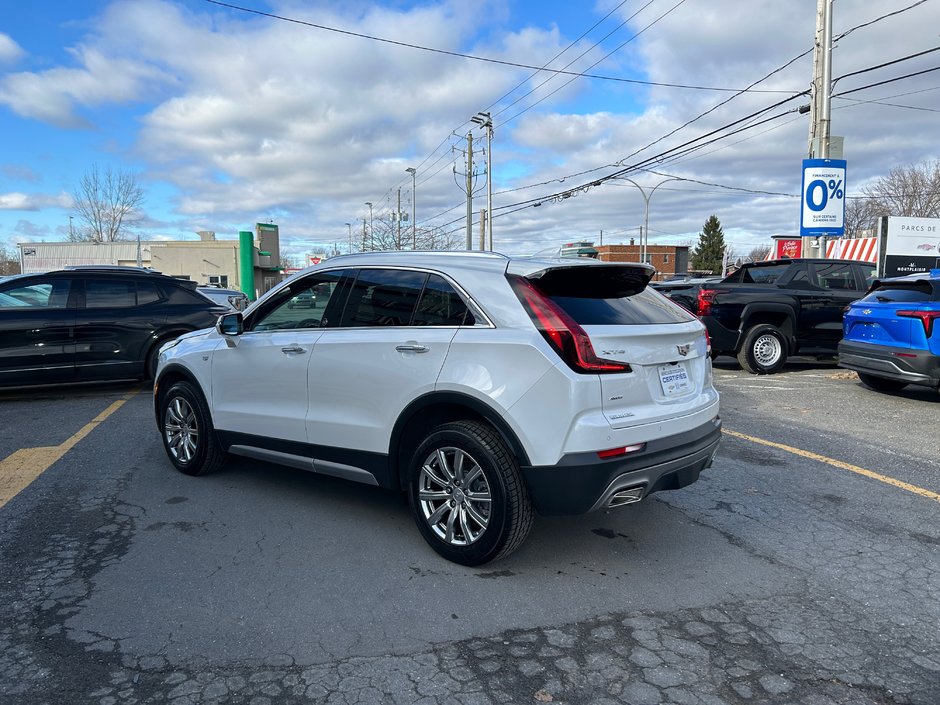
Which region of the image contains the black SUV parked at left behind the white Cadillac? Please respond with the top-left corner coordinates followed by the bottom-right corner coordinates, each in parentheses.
top-left (0, 267), bottom-right (229, 387)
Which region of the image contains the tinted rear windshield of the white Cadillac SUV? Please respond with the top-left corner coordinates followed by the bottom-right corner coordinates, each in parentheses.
top-left (549, 289), bottom-right (695, 326)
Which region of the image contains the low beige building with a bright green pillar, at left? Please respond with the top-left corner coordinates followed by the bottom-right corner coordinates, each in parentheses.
top-left (19, 223), bottom-right (282, 299)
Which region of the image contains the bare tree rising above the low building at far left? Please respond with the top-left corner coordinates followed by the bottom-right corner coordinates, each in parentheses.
top-left (69, 164), bottom-right (144, 242)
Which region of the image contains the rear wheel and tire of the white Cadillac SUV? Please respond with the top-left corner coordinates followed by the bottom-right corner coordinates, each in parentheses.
top-left (408, 421), bottom-right (534, 566)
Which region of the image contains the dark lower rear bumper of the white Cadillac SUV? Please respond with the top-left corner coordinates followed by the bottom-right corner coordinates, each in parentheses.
top-left (522, 416), bottom-right (721, 515)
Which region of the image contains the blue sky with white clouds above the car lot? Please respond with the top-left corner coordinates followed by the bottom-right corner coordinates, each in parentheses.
top-left (0, 0), bottom-right (940, 262)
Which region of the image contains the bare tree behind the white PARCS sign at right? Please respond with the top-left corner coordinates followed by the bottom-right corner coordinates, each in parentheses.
top-left (862, 159), bottom-right (940, 218)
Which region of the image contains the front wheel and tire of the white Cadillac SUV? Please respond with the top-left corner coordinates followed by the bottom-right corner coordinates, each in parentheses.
top-left (159, 381), bottom-right (225, 475)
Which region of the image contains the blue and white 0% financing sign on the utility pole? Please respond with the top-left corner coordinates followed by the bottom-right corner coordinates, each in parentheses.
top-left (800, 159), bottom-right (846, 237)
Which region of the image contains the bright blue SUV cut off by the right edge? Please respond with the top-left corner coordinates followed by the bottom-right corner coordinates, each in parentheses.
top-left (839, 269), bottom-right (940, 392)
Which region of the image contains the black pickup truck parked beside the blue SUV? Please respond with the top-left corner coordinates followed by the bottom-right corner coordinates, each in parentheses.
top-left (698, 259), bottom-right (875, 374)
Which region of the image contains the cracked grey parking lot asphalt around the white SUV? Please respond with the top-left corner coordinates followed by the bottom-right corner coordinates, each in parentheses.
top-left (0, 358), bottom-right (940, 705)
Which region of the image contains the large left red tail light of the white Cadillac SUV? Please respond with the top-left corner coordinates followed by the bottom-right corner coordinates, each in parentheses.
top-left (506, 274), bottom-right (630, 374)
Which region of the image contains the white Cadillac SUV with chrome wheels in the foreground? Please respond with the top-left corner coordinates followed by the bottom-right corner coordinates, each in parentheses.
top-left (153, 252), bottom-right (721, 565)
